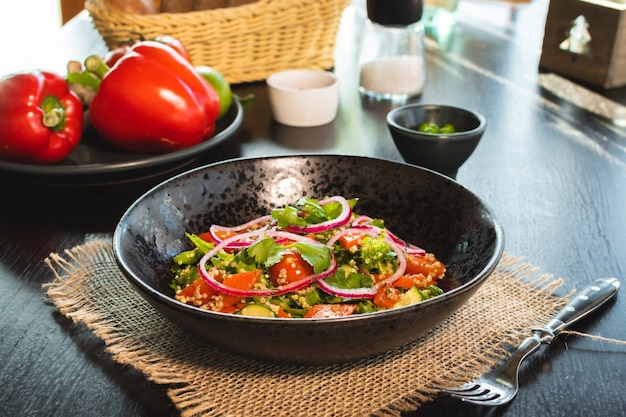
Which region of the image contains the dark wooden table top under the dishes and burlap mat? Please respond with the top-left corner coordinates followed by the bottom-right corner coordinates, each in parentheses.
top-left (0, 0), bottom-right (626, 417)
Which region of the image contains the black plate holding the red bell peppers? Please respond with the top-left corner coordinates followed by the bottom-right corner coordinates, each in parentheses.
top-left (0, 100), bottom-right (243, 185)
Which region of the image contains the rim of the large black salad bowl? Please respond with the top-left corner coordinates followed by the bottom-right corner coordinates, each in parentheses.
top-left (112, 153), bottom-right (504, 326)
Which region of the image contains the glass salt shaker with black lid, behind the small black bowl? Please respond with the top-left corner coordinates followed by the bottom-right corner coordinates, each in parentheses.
top-left (359, 0), bottom-right (426, 101)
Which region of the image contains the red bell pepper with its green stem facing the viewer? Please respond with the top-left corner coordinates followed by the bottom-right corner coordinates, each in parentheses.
top-left (0, 71), bottom-right (83, 164)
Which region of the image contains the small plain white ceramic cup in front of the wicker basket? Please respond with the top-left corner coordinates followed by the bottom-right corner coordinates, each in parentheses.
top-left (267, 69), bottom-right (339, 127)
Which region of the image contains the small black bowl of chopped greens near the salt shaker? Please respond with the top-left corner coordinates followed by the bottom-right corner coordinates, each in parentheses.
top-left (387, 104), bottom-right (487, 178)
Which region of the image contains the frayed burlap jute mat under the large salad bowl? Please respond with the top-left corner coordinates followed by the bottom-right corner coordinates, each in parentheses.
top-left (45, 239), bottom-right (571, 417)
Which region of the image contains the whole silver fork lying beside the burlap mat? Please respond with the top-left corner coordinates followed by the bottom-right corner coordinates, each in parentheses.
top-left (434, 278), bottom-right (620, 406)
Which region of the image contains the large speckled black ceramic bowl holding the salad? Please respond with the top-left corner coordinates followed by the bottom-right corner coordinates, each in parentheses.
top-left (113, 155), bottom-right (503, 364)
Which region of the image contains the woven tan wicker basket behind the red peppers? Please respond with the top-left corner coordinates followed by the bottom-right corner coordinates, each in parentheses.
top-left (85, 0), bottom-right (350, 83)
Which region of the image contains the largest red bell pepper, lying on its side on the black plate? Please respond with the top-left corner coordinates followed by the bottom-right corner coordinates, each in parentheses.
top-left (89, 41), bottom-right (220, 153)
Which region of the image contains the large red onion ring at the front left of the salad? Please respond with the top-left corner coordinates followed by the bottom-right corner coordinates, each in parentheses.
top-left (198, 230), bottom-right (337, 297)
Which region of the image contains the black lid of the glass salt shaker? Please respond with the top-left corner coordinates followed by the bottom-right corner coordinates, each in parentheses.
top-left (367, 0), bottom-right (424, 26)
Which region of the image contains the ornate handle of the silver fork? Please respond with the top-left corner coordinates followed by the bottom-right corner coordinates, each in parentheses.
top-left (534, 278), bottom-right (620, 343)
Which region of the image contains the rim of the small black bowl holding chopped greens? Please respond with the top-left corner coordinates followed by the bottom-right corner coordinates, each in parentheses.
top-left (387, 103), bottom-right (487, 140)
